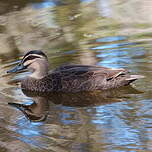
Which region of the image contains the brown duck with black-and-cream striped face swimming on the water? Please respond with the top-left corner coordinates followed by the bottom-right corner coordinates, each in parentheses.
top-left (7, 50), bottom-right (144, 93)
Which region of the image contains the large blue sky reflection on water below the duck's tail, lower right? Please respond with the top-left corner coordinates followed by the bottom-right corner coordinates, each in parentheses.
top-left (89, 101), bottom-right (150, 151)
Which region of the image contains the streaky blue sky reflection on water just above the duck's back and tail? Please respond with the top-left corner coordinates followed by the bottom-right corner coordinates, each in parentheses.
top-left (91, 36), bottom-right (145, 68)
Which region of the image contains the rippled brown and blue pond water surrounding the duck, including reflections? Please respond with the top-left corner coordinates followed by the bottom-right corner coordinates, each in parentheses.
top-left (0, 0), bottom-right (152, 152)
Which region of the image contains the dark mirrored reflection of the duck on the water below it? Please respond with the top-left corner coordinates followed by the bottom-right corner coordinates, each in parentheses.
top-left (9, 86), bottom-right (142, 122)
